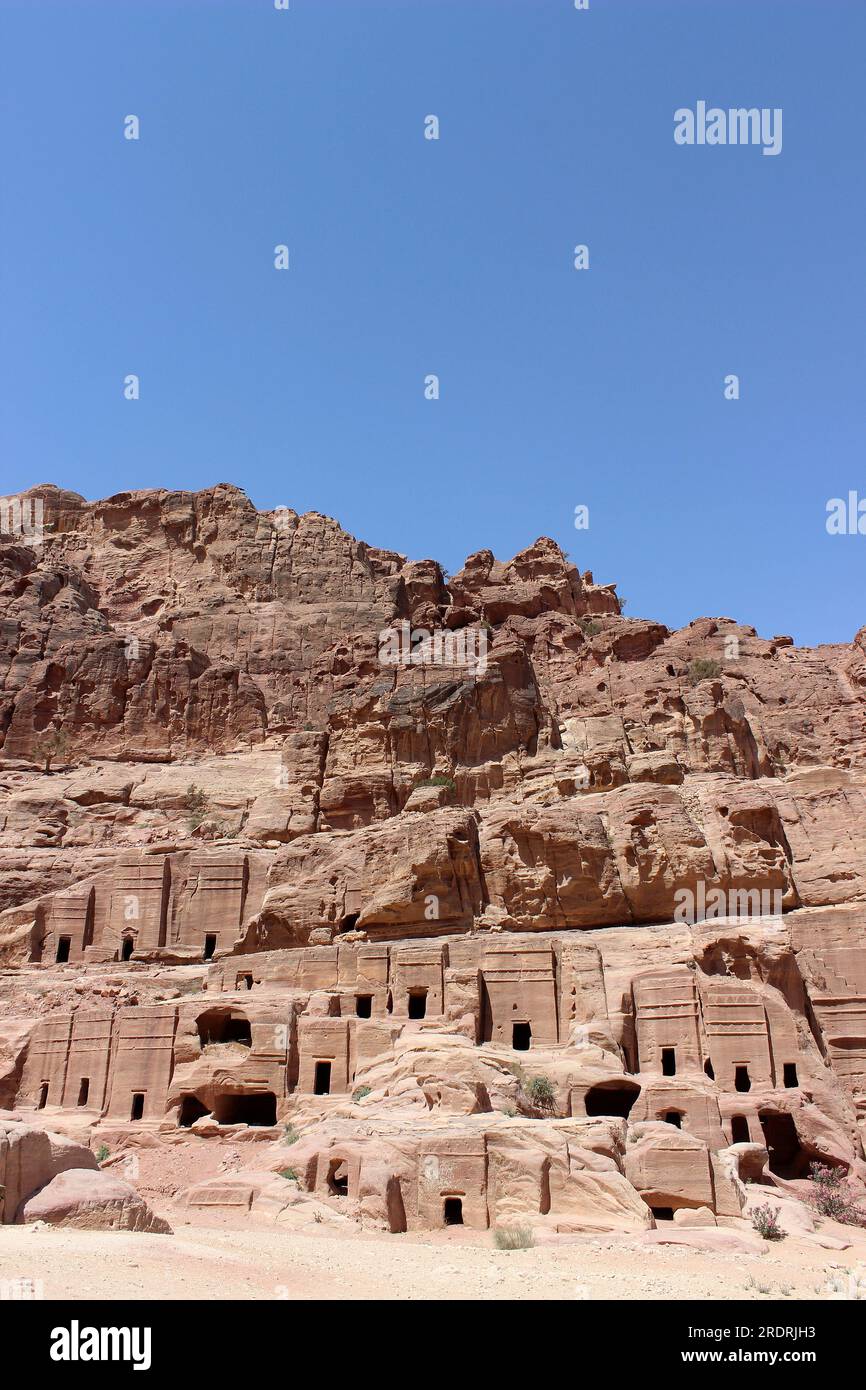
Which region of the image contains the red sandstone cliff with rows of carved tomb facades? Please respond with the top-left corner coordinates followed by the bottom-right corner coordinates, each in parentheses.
top-left (0, 485), bottom-right (866, 1238)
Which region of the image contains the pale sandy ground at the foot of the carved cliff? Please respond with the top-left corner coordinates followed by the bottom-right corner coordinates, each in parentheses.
top-left (0, 1213), bottom-right (866, 1301)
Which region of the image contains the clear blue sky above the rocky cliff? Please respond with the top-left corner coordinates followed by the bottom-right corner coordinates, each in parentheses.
top-left (0, 0), bottom-right (866, 644)
